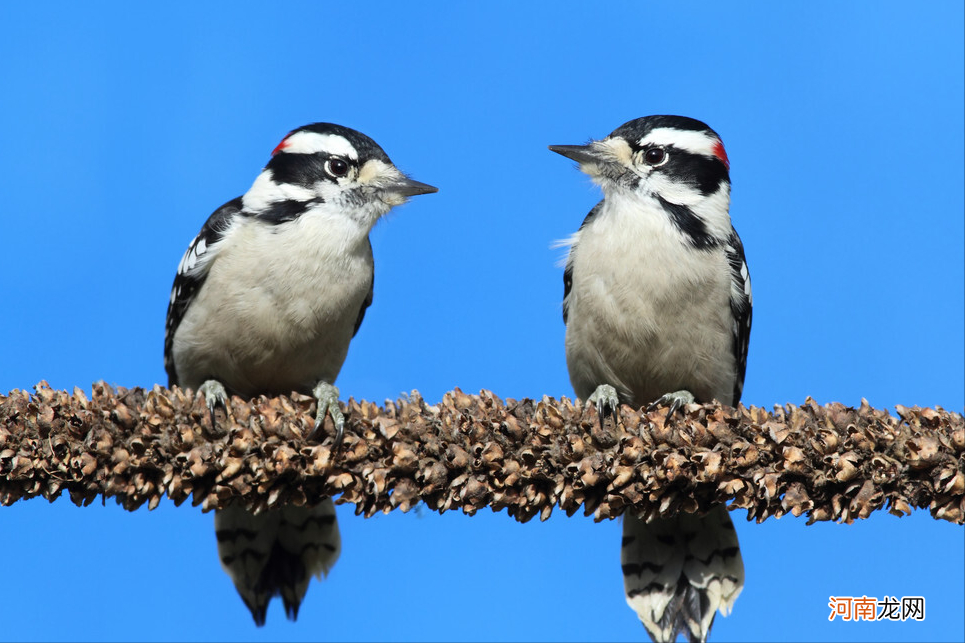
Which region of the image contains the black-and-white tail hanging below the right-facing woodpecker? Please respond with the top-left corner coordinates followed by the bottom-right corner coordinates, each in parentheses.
top-left (214, 498), bottom-right (341, 626)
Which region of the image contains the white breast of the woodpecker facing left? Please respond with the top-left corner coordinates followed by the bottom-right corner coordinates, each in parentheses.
top-left (566, 197), bottom-right (736, 404)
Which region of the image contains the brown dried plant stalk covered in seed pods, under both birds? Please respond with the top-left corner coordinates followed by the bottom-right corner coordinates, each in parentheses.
top-left (0, 382), bottom-right (965, 524)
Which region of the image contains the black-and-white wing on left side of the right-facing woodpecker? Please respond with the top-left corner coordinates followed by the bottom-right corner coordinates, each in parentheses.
top-left (164, 197), bottom-right (240, 386)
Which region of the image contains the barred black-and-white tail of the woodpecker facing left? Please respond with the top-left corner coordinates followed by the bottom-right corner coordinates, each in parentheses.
top-left (621, 505), bottom-right (744, 643)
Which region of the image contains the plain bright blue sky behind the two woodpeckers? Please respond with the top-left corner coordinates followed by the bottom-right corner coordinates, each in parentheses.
top-left (0, 1), bottom-right (965, 641)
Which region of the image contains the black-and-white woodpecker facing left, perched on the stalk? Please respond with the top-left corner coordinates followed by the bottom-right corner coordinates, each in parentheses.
top-left (549, 115), bottom-right (752, 643)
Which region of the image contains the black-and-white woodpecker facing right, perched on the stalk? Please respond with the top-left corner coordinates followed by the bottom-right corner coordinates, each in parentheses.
top-left (164, 123), bottom-right (438, 626)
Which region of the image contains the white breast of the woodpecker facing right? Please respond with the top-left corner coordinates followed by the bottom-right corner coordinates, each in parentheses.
top-left (173, 204), bottom-right (373, 395)
